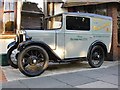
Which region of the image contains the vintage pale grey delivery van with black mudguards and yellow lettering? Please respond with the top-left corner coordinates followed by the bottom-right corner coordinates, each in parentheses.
top-left (8, 12), bottom-right (112, 76)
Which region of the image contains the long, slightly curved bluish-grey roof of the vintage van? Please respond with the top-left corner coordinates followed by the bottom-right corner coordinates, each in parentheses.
top-left (55, 12), bottom-right (112, 20)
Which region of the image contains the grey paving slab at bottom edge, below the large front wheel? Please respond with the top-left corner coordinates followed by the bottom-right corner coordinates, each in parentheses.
top-left (20, 77), bottom-right (71, 88)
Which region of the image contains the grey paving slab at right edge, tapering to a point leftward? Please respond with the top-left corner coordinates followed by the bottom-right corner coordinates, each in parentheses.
top-left (76, 66), bottom-right (119, 85)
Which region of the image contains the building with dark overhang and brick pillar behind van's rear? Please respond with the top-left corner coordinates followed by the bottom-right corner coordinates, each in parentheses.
top-left (45, 0), bottom-right (120, 60)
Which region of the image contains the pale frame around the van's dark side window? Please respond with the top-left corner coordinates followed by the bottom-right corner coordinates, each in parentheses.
top-left (65, 15), bottom-right (91, 32)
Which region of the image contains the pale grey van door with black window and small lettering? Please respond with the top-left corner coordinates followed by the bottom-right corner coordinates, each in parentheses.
top-left (65, 16), bottom-right (91, 58)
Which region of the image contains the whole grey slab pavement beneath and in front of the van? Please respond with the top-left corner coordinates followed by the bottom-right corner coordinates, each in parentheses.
top-left (1, 61), bottom-right (120, 89)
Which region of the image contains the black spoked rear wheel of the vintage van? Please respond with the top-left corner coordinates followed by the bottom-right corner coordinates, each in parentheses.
top-left (88, 45), bottom-right (105, 68)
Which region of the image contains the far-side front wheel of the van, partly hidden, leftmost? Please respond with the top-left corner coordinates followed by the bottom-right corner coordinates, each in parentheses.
top-left (7, 46), bottom-right (18, 68)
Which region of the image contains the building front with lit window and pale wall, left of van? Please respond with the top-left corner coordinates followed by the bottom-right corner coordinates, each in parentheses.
top-left (0, 0), bottom-right (44, 65)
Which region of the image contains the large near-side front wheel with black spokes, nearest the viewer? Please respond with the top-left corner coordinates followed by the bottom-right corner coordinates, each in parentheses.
top-left (18, 46), bottom-right (49, 77)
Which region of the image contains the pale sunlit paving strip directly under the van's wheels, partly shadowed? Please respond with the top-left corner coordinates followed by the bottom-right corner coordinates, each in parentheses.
top-left (2, 61), bottom-right (118, 82)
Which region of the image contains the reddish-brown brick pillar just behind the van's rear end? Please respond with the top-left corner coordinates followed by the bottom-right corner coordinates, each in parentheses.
top-left (108, 3), bottom-right (118, 60)
